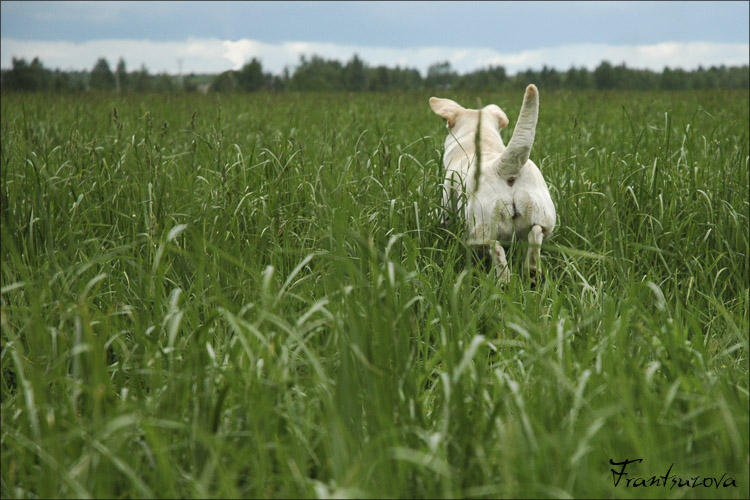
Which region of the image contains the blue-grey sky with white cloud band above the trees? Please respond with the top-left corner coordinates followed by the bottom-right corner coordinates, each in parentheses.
top-left (0, 0), bottom-right (750, 75)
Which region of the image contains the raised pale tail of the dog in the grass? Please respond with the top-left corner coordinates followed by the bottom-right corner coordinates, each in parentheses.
top-left (497, 84), bottom-right (539, 177)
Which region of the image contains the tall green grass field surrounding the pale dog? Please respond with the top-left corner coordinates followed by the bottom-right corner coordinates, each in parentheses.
top-left (0, 88), bottom-right (750, 498)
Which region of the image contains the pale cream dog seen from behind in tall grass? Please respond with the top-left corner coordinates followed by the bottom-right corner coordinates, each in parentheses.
top-left (430, 85), bottom-right (555, 285)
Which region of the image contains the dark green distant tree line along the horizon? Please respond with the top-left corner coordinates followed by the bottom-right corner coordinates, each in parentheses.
top-left (0, 54), bottom-right (750, 92)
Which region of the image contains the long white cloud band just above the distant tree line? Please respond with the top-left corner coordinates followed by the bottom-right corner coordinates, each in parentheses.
top-left (0, 38), bottom-right (750, 74)
